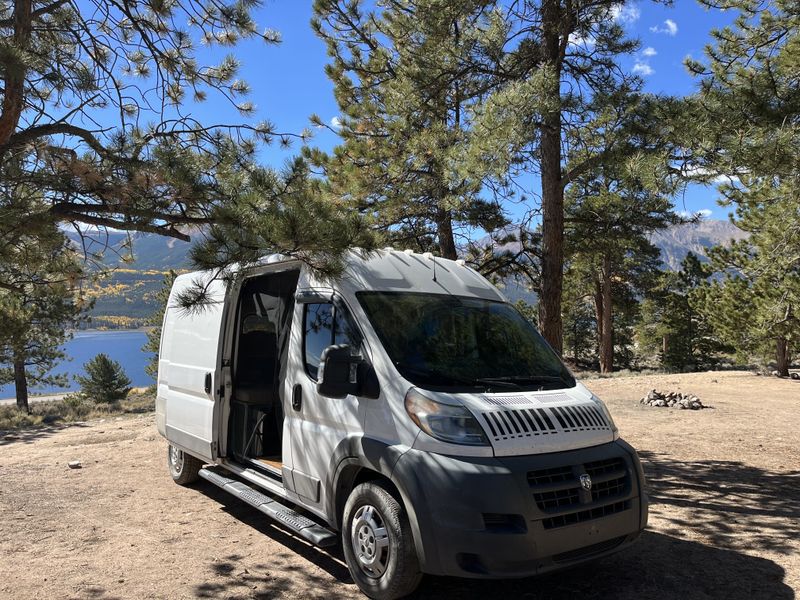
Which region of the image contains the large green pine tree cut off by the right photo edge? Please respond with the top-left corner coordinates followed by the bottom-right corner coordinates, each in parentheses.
top-left (686, 0), bottom-right (800, 375)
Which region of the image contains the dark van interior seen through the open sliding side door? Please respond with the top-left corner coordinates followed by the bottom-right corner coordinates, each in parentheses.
top-left (228, 270), bottom-right (300, 474)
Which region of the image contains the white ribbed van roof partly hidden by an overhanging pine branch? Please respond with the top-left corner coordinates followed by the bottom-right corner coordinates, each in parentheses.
top-left (173, 248), bottom-right (505, 301)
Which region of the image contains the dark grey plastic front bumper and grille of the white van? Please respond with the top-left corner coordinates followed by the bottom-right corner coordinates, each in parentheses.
top-left (393, 440), bottom-right (647, 577)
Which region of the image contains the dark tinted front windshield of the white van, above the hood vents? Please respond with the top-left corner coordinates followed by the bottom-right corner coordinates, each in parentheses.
top-left (357, 292), bottom-right (575, 392)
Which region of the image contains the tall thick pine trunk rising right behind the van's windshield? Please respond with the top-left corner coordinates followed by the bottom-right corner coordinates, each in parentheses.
top-left (539, 0), bottom-right (564, 354)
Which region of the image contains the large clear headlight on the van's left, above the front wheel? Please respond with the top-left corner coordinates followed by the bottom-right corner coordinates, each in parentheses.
top-left (406, 388), bottom-right (489, 446)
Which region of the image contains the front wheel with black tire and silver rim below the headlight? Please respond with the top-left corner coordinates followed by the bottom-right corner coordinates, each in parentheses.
top-left (342, 481), bottom-right (422, 600)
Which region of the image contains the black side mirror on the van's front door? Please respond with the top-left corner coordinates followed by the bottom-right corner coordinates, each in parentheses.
top-left (317, 344), bottom-right (380, 398)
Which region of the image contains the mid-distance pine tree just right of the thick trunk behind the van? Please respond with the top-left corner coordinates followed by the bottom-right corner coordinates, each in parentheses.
top-left (565, 87), bottom-right (679, 373)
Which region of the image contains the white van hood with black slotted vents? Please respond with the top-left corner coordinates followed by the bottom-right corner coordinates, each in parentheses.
top-left (426, 383), bottom-right (618, 456)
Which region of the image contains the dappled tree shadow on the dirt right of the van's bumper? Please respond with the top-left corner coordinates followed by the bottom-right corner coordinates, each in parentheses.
top-left (640, 452), bottom-right (800, 554)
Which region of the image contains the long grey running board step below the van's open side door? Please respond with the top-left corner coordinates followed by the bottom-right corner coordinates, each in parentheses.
top-left (199, 467), bottom-right (338, 548)
